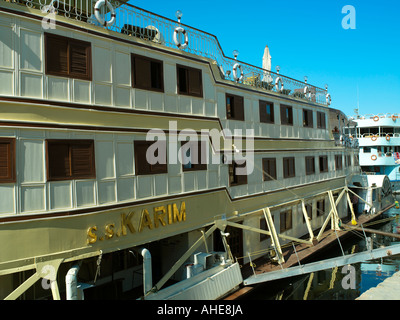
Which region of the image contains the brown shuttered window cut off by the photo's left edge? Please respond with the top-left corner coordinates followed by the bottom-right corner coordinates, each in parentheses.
top-left (0, 138), bottom-right (16, 183)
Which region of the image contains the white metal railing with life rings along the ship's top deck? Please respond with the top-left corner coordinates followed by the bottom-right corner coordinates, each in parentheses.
top-left (0, 0), bottom-right (330, 105)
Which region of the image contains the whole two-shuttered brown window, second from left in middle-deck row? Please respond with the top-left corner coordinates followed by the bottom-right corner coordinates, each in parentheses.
top-left (46, 140), bottom-right (96, 181)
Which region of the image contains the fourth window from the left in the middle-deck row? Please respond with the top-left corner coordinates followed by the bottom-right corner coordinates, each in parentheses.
top-left (181, 141), bottom-right (207, 171)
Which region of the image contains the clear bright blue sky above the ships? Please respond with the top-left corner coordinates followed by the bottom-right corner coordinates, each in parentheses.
top-left (129, 0), bottom-right (400, 116)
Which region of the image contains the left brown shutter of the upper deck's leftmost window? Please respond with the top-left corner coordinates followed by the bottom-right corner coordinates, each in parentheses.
top-left (46, 36), bottom-right (69, 75)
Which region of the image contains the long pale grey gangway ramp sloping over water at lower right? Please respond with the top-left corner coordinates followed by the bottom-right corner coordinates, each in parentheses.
top-left (243, 244), bottom-right (400, 286)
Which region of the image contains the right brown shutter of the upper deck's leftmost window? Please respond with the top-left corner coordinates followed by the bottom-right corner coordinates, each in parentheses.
top-left (69, 41), bottom-right (90, 78)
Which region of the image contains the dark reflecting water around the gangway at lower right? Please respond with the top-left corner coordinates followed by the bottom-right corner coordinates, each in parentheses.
top-left (244, 208), bottom-right (400, 300)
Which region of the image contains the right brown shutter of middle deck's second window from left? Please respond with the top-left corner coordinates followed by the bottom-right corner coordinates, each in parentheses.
top-left (71, 141), bottom-right (95, 178)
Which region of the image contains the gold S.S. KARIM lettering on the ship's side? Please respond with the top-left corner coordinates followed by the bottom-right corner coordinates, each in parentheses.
top-left (87, 202), bottom-right (186, 245)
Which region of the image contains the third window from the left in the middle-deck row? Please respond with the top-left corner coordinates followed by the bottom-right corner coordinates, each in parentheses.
top-left (134, 141), bottom-right (168, 175)
